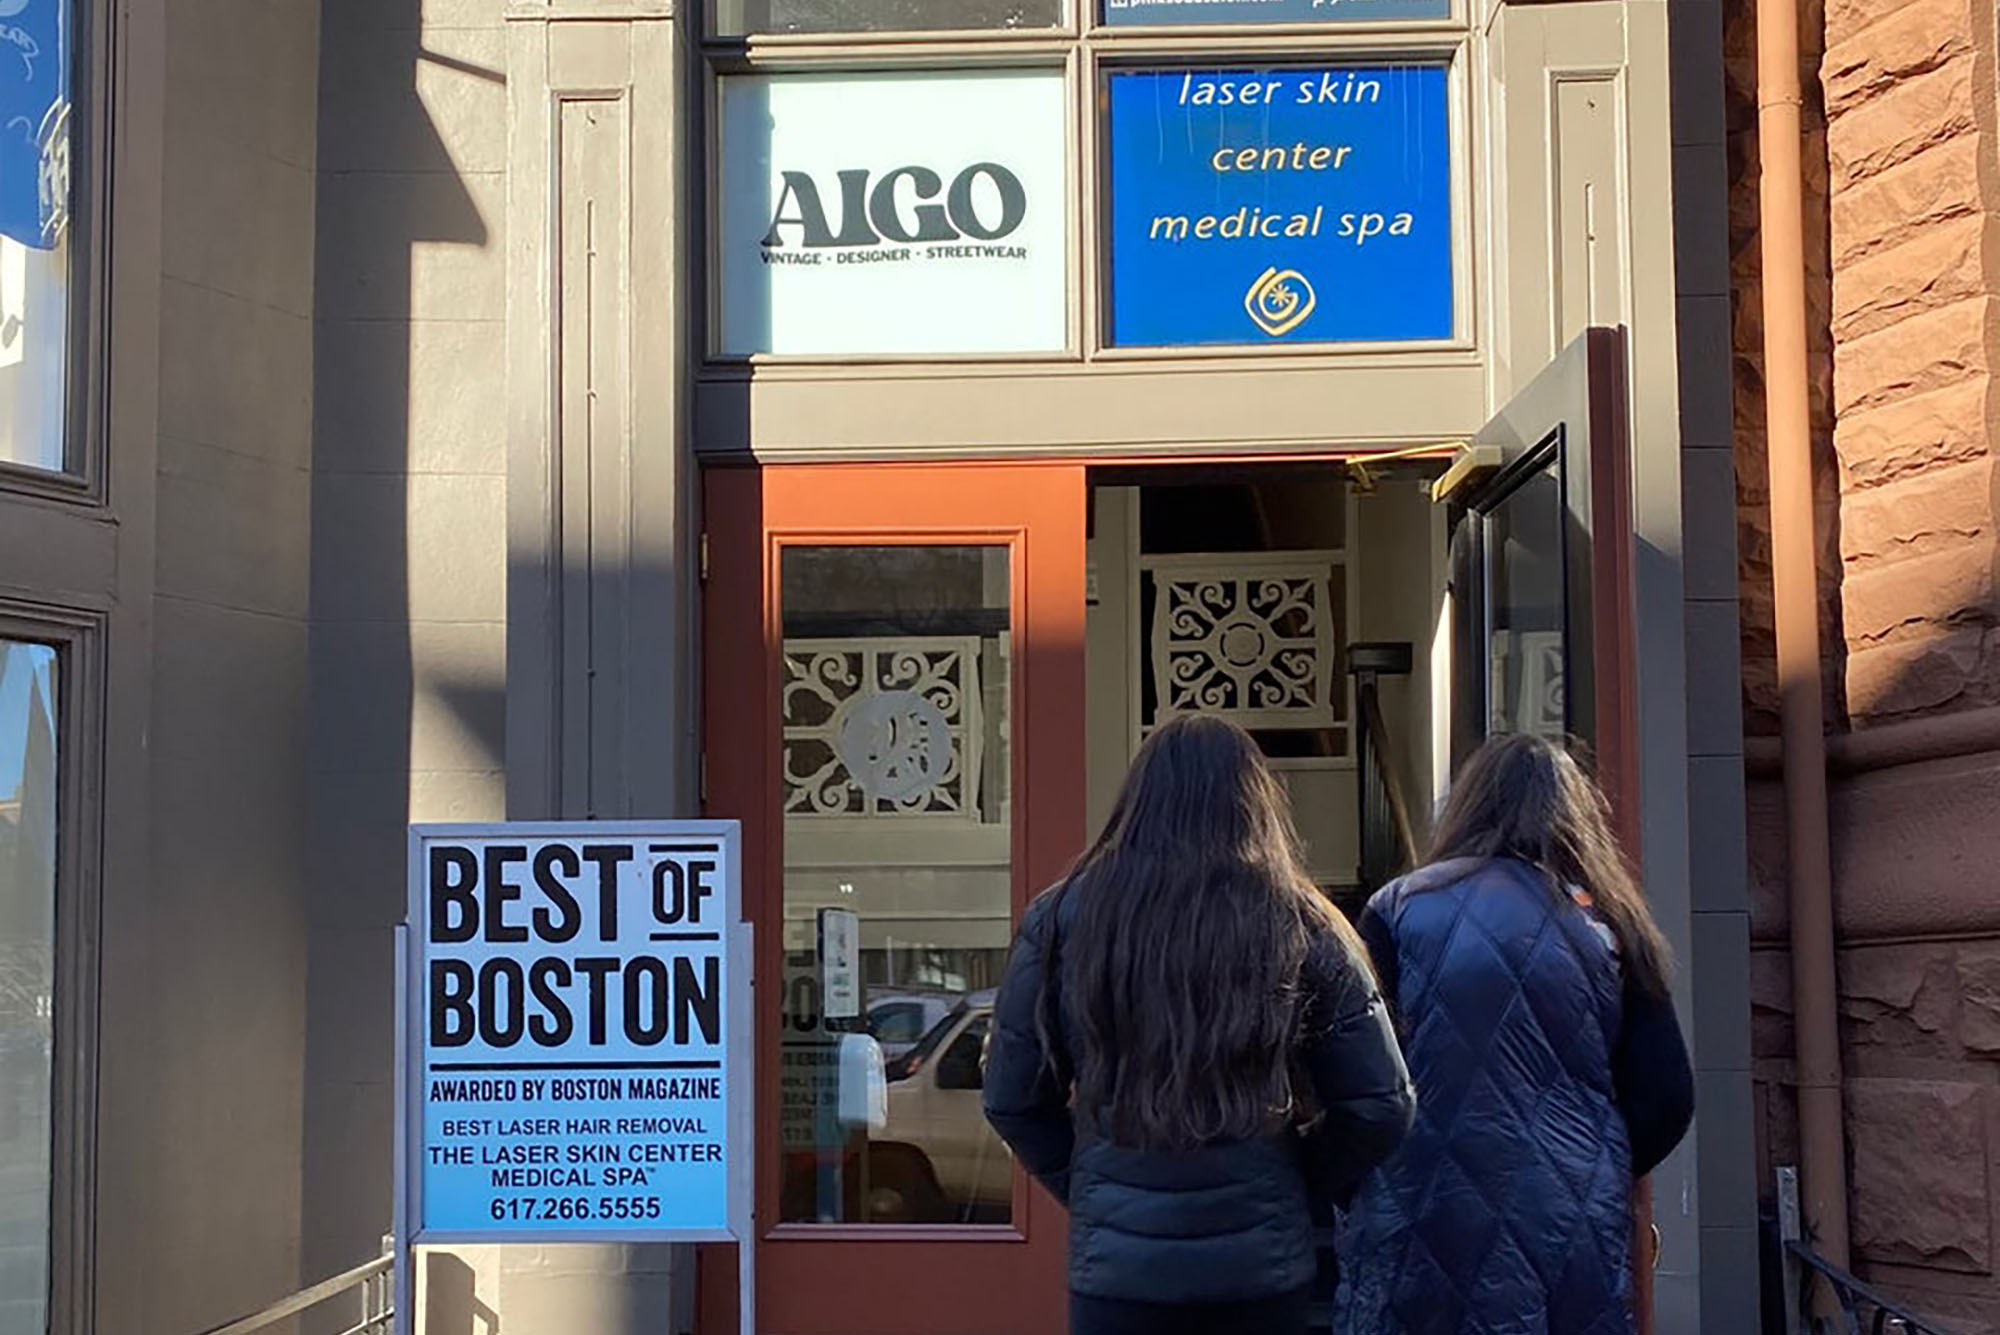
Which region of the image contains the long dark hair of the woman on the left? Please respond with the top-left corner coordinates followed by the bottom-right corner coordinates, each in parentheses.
top-left (1042, 715), bottom-right (1368, 1149)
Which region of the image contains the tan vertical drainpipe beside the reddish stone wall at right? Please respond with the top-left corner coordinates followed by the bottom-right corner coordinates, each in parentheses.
top-left (1756, 0), bottom-right (1848, 1269)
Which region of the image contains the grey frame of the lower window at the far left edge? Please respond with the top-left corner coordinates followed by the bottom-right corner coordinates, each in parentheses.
top-left (0, 596), bottom-right (108, 1335)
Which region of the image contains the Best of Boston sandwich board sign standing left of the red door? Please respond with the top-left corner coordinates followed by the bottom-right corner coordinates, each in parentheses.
top-left (396, 821), bottom-right (754, 1329)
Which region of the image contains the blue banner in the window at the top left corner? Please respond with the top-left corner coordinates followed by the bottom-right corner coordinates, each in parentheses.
top-left (0, 0), bottom-right (70, 250)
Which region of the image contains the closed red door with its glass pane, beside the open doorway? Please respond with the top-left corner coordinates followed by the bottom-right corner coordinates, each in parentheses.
top-left (700, 464), bottom-right (1086, 1335)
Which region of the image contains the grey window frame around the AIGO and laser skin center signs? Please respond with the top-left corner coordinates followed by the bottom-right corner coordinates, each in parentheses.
top-left (688, 0), bottom-right (1496, 367)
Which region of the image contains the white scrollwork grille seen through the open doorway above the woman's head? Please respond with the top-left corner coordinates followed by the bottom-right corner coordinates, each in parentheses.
top-left (1140, 552), bottom-right (1346, 727)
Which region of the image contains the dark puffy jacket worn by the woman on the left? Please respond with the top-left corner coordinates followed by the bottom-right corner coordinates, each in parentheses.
top-left (984, 891), bottom-right (1414, 1303)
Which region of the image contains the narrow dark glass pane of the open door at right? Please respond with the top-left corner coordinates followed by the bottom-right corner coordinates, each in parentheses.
top-left (1486, 460), bottom-right (1568, 737)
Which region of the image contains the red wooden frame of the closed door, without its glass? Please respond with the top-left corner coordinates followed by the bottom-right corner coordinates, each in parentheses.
top-left (698, 462), bottom-right (1088, 1335)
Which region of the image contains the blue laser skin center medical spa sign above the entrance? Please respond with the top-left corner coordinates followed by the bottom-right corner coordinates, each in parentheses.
top-left (1108, 64), bottom-right (1456, 348)
